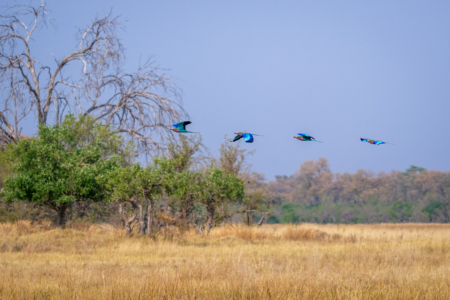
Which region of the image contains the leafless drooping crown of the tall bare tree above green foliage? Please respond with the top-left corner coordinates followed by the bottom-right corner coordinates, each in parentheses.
top-left (0, 2), bottom-right (186, 150)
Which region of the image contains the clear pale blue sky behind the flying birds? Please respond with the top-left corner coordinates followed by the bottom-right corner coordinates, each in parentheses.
top-left (10, 0), bottom-right (450, 179)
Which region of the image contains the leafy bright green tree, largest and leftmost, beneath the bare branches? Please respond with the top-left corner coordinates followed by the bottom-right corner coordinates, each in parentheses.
top-left (1, 125), bottom-right (119, 226)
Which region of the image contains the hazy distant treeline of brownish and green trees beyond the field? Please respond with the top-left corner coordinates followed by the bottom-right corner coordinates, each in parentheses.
top-left (262, 158), bottom-right (450, 223)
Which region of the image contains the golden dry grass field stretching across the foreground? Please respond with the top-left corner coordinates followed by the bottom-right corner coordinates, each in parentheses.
top-left (0, 222), bottom-right (450, 299)
